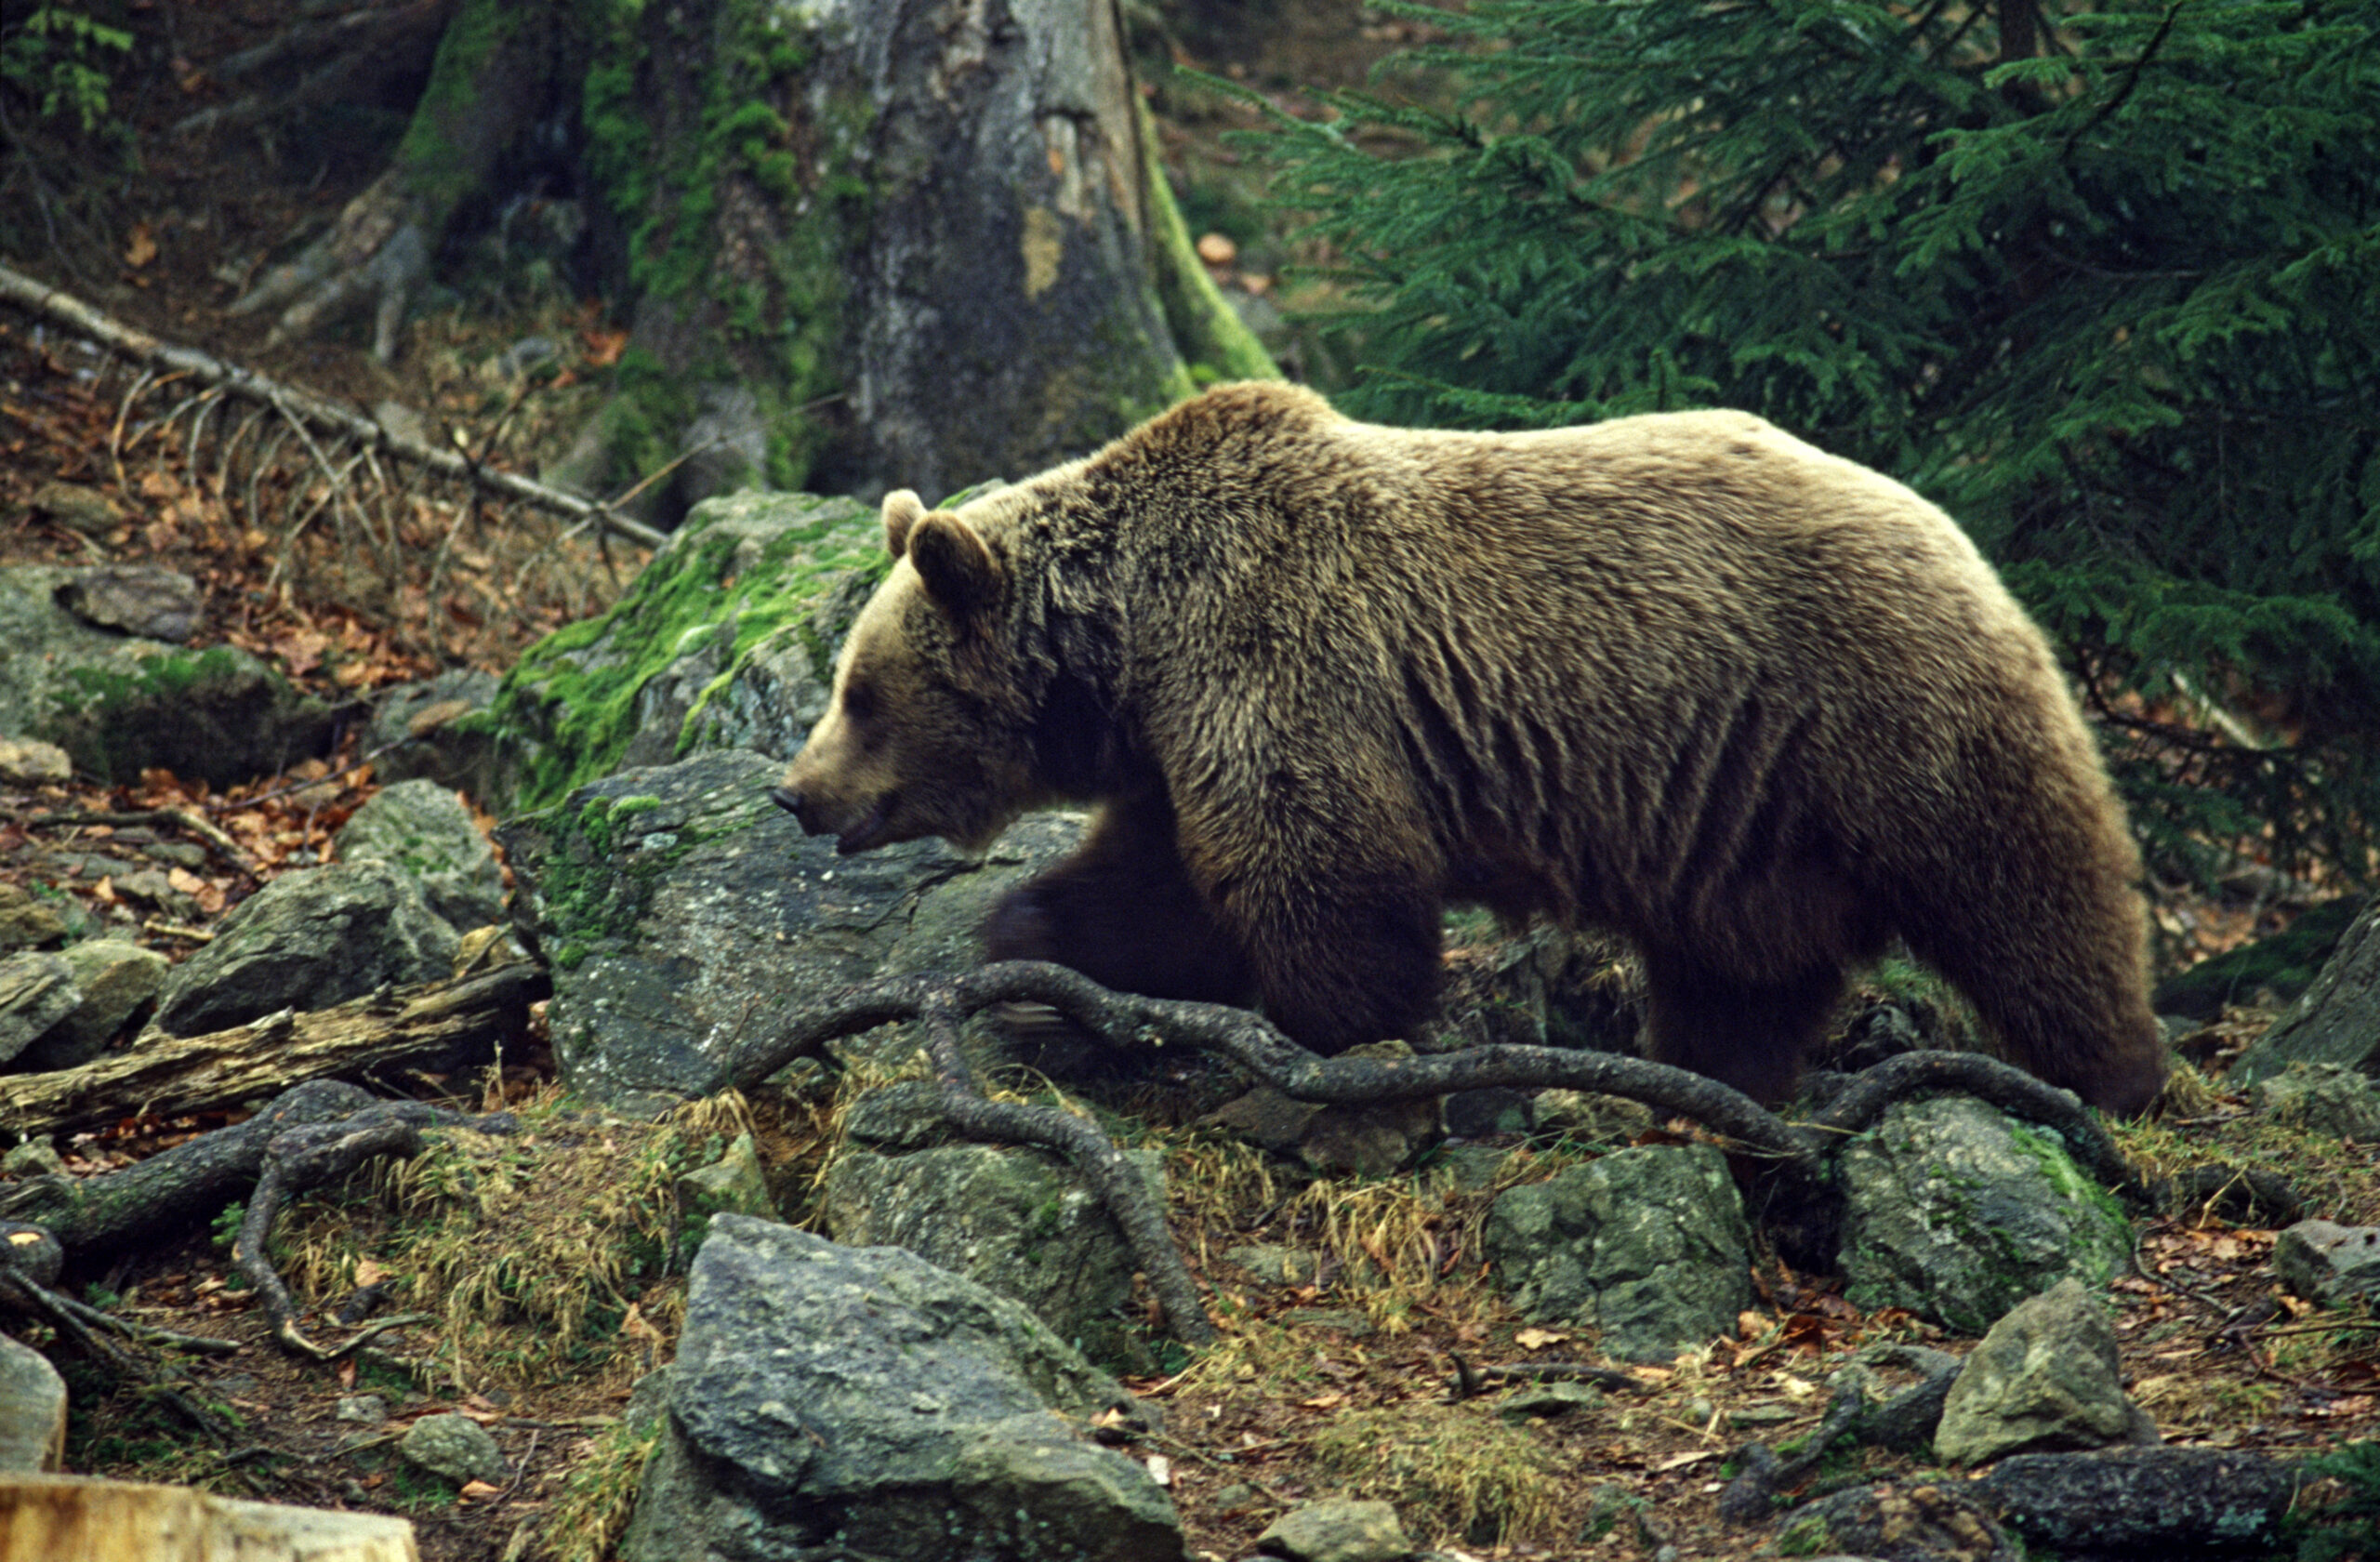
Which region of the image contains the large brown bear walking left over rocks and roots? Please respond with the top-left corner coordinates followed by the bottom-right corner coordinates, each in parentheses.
top-left (776, 383), bottom-right (2166, 1112)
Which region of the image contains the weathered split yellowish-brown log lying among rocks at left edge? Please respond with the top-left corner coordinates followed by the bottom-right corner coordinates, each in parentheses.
top-left (0, 962), bottom-right (549, 1138)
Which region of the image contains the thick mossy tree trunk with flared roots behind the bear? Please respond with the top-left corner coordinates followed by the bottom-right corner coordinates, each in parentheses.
top-left (227, 0), bottom-right (1274, 519)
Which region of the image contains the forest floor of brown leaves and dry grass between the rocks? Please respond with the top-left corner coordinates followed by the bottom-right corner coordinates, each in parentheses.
top-left (0, 5), bottom-right (2380, 1562)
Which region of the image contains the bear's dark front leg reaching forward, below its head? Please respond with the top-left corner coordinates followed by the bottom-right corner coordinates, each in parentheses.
top-left (983, 798), bottom-right (1257, 1007)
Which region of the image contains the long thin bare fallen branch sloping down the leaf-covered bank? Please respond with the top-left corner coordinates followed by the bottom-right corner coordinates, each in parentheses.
top-left (0, 267), bottom-right (668, 548)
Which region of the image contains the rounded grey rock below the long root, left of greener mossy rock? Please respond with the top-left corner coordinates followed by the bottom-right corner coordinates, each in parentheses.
top-left (1483, 1145), bottom-right (1752, 1362)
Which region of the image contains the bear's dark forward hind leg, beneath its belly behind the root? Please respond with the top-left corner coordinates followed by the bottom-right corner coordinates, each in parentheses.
top-left (1645, 952), bottom-right (1842, 1105)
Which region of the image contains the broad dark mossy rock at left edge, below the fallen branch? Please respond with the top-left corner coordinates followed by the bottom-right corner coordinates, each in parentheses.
top-left (0, 564), bottom-right (331, 786)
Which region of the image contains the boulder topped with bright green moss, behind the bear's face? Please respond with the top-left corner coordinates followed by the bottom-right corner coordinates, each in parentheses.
top-left (481, 493), bottom-right (890, 812)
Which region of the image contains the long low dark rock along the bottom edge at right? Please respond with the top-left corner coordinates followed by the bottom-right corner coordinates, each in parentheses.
top-left (1968, 1448), bottom-right (2302, 1557)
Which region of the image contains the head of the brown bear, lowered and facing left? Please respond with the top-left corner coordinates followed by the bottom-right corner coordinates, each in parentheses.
top-left (771, 488), bottom-right (1038, 854)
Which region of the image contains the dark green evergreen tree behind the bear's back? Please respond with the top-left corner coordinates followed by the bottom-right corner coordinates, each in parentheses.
top-left (1257, 0), bottom-right (2380, 879)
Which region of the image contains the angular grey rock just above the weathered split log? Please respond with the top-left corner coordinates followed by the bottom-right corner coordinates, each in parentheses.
top-left (157, 862), bottom-right (459, 1036)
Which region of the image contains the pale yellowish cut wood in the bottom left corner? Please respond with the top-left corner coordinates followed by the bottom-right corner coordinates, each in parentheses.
top-left (0, 1474), bottom-right (421, 1562)
